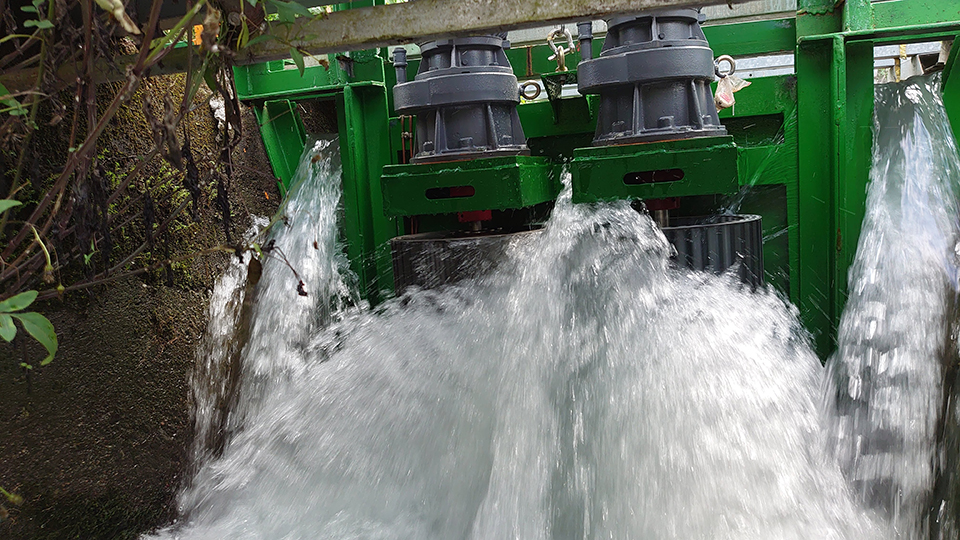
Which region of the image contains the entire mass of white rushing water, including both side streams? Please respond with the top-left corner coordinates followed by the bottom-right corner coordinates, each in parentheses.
top-left (148, 75), bottom-right (956, 540)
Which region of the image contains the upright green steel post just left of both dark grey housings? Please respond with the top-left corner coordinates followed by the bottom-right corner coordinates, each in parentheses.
top-left (337, 85), bottom-right (400, 304)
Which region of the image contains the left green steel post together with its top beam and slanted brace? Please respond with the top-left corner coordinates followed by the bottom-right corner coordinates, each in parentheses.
top-left (234, 0), bottom-right (403, 303)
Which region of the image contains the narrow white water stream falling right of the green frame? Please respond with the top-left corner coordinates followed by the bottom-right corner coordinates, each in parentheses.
top-left (828, 74), bottom-right (960, 537)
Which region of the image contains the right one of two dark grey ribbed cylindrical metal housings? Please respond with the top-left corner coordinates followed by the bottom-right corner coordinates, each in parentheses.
top-left (577, 9), bottom-right (727, 146)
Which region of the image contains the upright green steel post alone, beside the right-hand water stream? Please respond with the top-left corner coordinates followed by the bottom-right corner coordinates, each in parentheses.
top-left (797, 34), bottom-right (873, 356)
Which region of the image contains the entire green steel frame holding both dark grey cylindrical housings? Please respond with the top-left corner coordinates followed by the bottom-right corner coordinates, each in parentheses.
top-left (235, 0), bottom-right (960, 356)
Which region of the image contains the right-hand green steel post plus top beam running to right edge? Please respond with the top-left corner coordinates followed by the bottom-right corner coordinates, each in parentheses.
top-left (796, 0), bottom-right (960, 354)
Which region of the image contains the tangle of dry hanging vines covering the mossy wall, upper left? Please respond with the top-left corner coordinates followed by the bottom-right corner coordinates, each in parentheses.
top-left (0, 0), bottom-right (315, 367)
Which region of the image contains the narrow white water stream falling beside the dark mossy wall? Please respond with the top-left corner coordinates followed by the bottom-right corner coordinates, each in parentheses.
top-left (220, 137), bottom-right (361, 431)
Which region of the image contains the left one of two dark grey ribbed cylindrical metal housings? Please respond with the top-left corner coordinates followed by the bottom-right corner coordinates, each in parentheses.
top-left (393, 34), bottom-right (529, 163)
